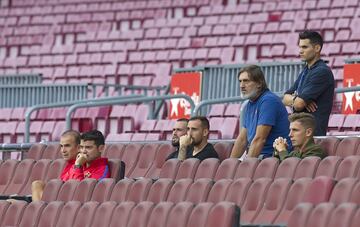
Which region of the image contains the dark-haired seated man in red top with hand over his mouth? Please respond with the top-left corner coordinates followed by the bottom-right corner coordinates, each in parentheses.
top-left (71, 130), bottom-right (110, 180)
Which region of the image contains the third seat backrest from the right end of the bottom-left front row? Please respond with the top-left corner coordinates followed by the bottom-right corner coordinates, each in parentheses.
top-left (166, 202), bottom-right (194, 227)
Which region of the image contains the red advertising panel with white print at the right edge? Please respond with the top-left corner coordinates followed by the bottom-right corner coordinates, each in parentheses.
top-left (342, 64), bottom-right (360, 114)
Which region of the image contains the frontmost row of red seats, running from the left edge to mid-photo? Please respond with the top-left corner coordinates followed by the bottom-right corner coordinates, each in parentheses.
top-left (0, 201), bottom-right (236, 227)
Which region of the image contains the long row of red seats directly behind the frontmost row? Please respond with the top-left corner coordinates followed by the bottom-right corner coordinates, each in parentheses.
top-left (33, 176), bottom-right (360, 224)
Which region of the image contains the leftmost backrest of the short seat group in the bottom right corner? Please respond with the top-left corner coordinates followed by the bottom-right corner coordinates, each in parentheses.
top-left (287, 203), bottom-right (314, 227)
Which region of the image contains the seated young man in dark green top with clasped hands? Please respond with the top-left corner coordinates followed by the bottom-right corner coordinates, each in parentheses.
top-left (273, 113), bottom-right (326, 160)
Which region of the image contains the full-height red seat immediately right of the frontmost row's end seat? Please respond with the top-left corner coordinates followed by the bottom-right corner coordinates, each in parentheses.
top-left (241, 178), bottom-right (272, 223)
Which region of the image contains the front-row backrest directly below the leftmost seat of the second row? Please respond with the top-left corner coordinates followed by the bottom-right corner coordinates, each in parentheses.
top-left (37, 201), bottom-right (64, 227)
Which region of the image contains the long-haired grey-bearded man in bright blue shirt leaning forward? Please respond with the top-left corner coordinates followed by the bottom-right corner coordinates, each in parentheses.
top-left (231, 65), bottom-right (290, 158)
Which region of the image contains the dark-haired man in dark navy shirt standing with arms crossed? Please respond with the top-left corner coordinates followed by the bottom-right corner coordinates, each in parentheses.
top-left (283, 31), bottom-right (335, 136)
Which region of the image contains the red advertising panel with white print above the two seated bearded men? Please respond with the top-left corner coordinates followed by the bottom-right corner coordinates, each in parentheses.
top-left (169, 72), bottom-right (201, 119)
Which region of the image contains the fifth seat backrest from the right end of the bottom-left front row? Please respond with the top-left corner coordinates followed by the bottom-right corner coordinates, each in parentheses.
top-left (127, 201), bottom-right (154, 227)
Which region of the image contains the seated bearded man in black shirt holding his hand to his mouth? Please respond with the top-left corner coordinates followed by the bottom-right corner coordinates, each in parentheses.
top-left (167, 116), bottom-right (219, 161)
